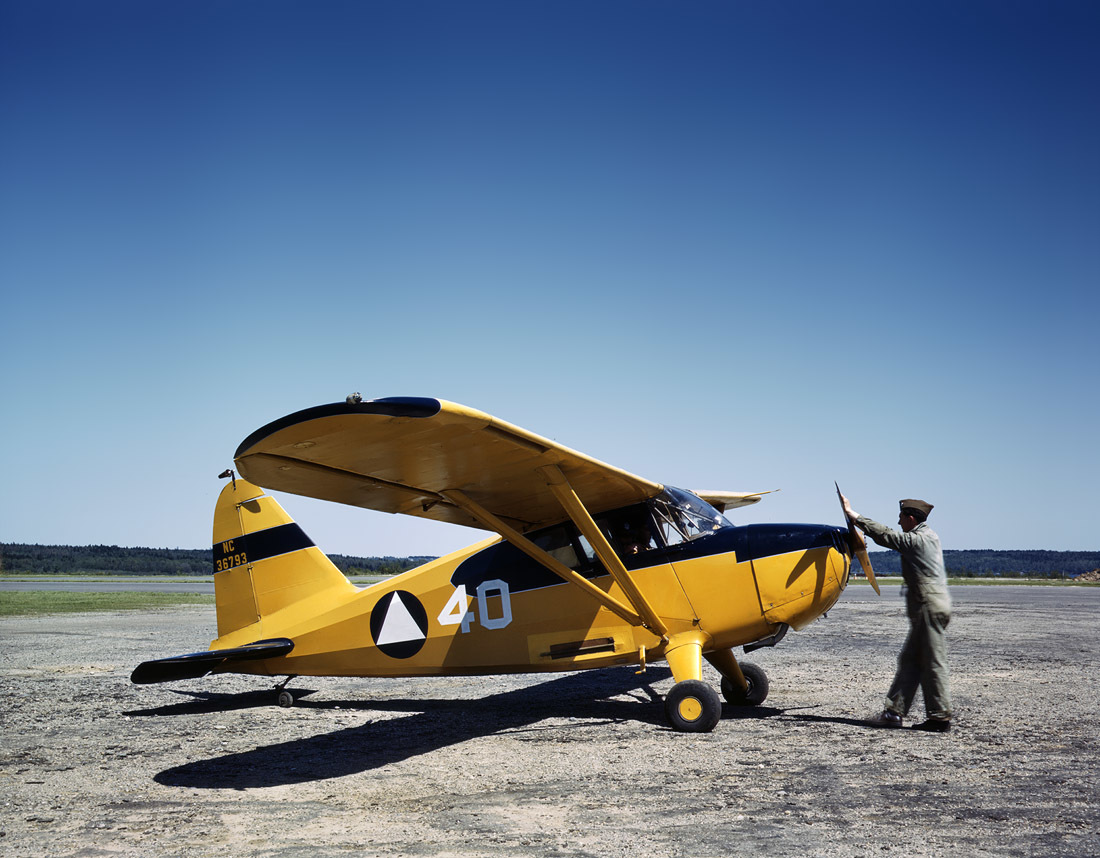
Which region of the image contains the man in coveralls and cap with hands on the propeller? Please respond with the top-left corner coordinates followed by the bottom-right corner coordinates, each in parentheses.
top-left (840, 495), bottom-right (952, 733)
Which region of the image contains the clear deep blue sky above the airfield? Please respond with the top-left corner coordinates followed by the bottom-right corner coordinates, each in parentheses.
top-left (0, 0), bottom-right (1100, 554)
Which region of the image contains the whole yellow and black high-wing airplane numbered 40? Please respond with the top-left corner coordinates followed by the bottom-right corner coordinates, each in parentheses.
top-left (131, 394), bottom-right (878, 733)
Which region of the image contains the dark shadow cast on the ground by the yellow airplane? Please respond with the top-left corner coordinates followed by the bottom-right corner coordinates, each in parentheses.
top-left (141, 668), bottom-right (686, 790)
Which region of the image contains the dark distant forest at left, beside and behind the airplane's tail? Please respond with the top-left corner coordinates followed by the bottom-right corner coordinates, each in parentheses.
top-left (0, 542), bottom-right (435, 575)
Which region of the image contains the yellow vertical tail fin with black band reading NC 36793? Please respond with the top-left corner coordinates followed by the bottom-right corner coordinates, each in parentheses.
top-left (213, 477), bottom-right (358, 639)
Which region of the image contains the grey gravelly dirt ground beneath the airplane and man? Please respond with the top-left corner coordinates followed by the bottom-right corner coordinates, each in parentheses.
top-left (0, 586), bottom-right (1100, 858)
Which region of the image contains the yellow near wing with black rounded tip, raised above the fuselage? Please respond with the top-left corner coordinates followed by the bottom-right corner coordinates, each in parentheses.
top-left (233, 397), bottom-right (662, 530)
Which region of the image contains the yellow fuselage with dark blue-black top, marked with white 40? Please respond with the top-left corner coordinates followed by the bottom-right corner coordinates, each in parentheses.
top-left (211, 481), bottom-right (850, 677)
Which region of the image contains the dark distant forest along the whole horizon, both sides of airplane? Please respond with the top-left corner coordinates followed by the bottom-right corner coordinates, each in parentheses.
top-left (0, 542), bottom-right (1100, 578)
